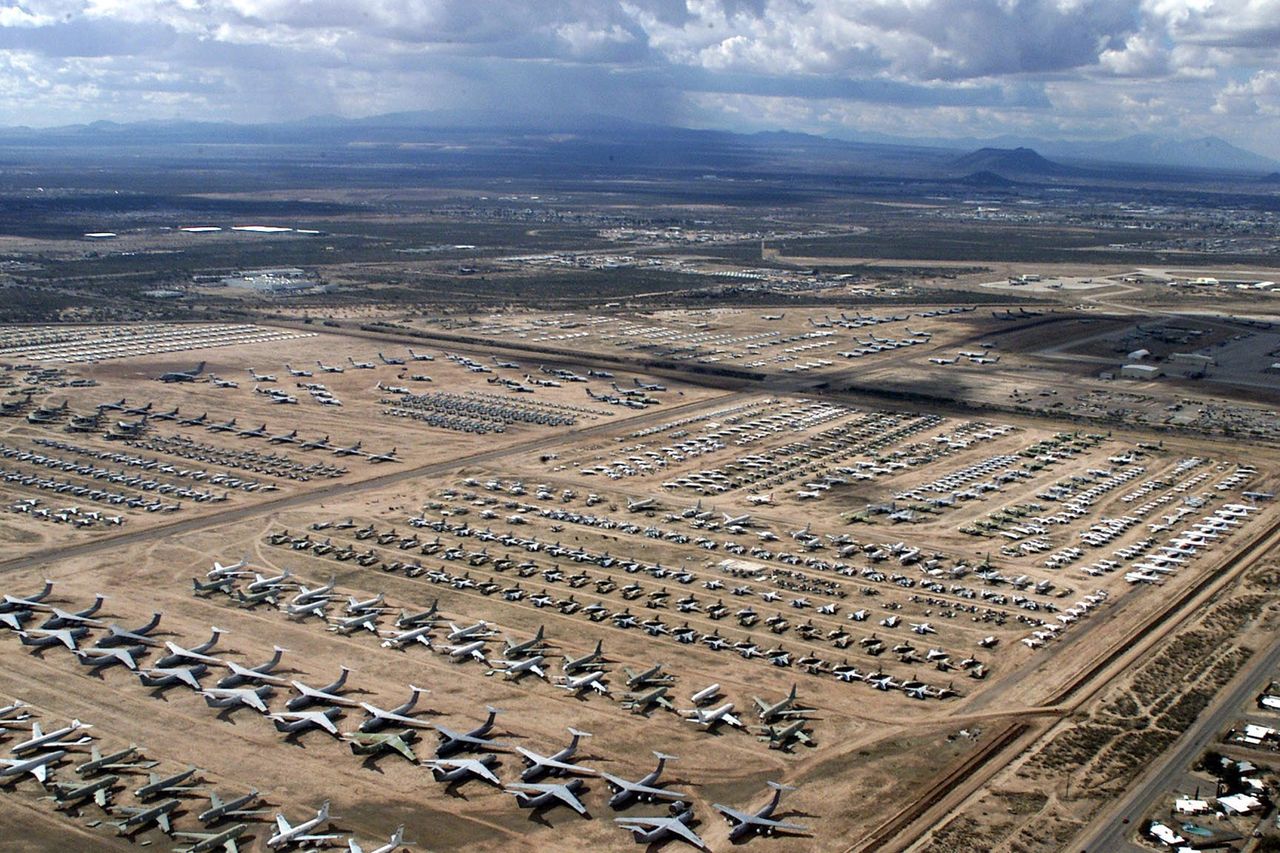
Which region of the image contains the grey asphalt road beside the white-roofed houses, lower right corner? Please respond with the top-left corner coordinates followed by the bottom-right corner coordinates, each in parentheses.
top-left (1073, 625), bottom-right (1280, 853)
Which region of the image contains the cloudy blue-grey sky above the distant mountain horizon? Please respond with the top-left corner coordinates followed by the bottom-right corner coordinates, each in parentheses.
top-left (0, 0), bottom-right (1280, 158)
